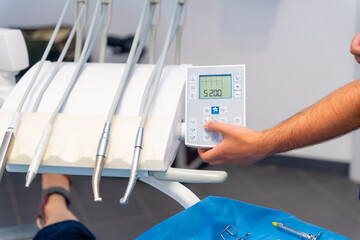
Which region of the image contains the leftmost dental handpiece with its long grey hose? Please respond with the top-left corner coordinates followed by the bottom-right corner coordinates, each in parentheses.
top-left (0, 0), bottom-right (70, 182)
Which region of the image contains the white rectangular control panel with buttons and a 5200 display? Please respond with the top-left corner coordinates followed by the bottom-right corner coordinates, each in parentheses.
top-left (185, 65), bottom-right (246, 148)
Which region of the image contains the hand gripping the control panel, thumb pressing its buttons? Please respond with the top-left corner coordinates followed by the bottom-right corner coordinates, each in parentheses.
top-left (198, 121), bottom-right (268, 166)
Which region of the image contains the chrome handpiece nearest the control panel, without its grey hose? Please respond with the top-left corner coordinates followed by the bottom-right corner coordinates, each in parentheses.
top-left (120, 127), bottom-right (144, 205)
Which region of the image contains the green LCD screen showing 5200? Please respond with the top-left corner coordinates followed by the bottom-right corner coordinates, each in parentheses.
top-left (199, 74), bottom-right (231, 99)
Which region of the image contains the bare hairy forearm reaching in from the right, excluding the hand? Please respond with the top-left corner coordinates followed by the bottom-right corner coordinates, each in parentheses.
top-left (262, 80), bottom-right (360, 155)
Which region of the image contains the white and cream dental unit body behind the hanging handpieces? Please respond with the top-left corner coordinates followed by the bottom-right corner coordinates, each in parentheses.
top-left (0, 62), bottom-right (186, 177)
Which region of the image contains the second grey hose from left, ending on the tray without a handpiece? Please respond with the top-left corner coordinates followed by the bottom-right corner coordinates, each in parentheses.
top-left (32, 1), bottom-right (87, 112)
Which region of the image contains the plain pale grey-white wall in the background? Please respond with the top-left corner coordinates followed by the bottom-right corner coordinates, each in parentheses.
top-left (0, 0), bottom-right (360, 162)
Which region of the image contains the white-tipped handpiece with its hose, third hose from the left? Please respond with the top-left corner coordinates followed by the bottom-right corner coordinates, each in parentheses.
top-left (25, 0), bottom-right (108, 187)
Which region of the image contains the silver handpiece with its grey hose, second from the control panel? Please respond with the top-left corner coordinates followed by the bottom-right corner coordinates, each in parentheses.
top-left (92, 0), bottom-right (158, 202)
